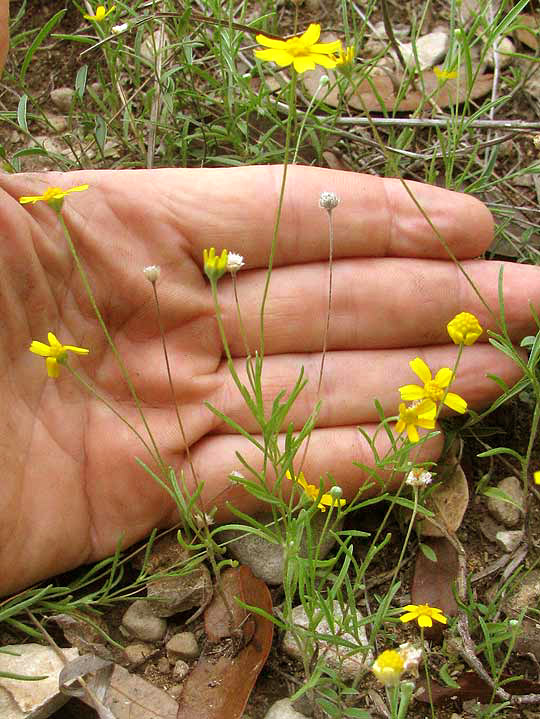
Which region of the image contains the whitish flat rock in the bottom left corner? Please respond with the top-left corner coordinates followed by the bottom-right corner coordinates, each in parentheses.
top-left (0, 643), bottom-right (79, 719)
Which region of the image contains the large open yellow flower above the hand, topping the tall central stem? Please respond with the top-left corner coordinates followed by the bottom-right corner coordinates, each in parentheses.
top-left (255, 23), bottom-right (341, 72)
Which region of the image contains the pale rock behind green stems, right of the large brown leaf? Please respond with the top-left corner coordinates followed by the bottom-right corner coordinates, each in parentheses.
top-left (282, 601), bottom-right (373, 680)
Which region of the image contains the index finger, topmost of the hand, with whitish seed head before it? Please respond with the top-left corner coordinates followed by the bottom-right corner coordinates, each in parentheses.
top-left (159, 166), bottom-right (493, 267)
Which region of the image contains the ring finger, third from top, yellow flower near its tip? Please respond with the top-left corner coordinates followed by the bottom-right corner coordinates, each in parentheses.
top-left (211, 345), bottom-right (521, 433)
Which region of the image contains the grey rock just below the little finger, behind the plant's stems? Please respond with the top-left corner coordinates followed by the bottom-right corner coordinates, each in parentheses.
top-left (220, 512), bottom-right (339, 584)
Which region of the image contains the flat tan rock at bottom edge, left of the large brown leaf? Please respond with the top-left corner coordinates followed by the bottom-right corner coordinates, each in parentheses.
top-left (104, 666), bottom-right (178, 719)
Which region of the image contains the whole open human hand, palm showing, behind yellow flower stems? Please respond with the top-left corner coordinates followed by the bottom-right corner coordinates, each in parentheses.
top-left (0, 167), bottom-right (540, 594)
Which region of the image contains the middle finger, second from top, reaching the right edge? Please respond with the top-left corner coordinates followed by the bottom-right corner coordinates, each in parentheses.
top-left (220, 258), bottom-right (540, 356)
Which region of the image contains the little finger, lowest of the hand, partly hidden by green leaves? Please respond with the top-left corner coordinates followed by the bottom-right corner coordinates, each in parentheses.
top-left (171, 425), bottom-right (443, 522)
